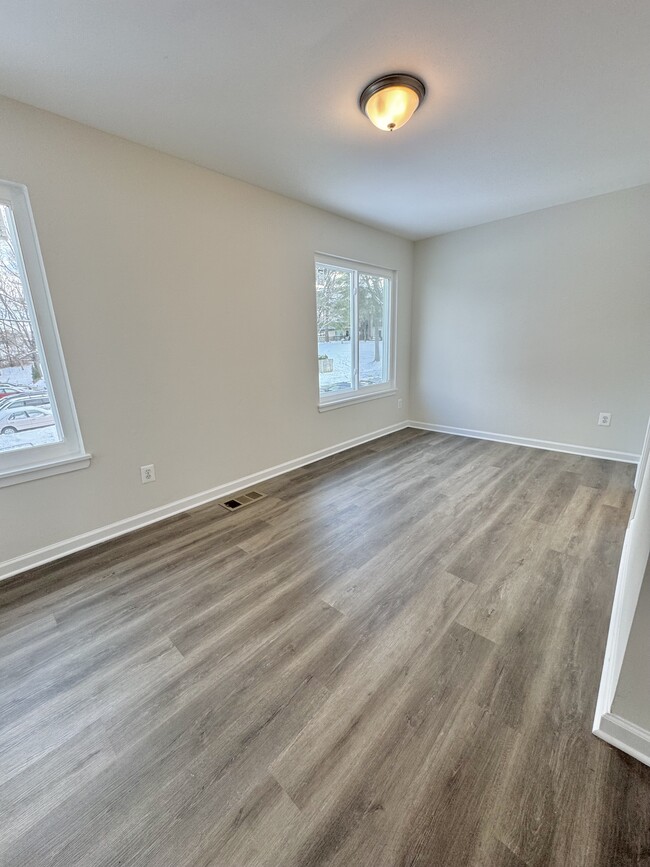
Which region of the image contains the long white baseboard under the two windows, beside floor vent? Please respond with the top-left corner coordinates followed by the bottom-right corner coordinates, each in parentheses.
top-left (0, 422), bottom-right (409, 581)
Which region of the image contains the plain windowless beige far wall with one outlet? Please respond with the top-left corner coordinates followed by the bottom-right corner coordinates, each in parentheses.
top-left (411, 186), bottom-right (650, 454)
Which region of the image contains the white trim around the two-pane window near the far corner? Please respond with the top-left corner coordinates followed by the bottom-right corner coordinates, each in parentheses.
top-left (314, 253), bottom-right (397, 412)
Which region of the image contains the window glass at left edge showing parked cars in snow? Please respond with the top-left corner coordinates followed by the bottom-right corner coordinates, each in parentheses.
top-left (0, 204), bottom-right (63, 453)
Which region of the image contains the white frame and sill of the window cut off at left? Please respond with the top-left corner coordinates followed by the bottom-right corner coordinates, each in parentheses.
top-left (0, 181), bottom-right (91, 487)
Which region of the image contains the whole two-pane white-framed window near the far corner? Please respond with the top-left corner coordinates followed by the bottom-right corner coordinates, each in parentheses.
top-left (316, 256), bottom-right (395, 409)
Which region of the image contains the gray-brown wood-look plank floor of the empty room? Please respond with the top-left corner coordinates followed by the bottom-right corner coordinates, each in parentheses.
top-left (0, 431), bottom-right (650, 867)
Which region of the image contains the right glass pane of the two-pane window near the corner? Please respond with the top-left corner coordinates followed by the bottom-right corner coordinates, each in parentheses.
top-left (358, 272), bottom-right (390, 388)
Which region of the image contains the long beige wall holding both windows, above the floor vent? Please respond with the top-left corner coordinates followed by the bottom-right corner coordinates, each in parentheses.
top-left (0, 99), bottom-right (413, 562)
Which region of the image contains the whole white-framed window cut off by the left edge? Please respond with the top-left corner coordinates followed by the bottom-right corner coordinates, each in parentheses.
top-left (0, 181), bottom-right (90, 487)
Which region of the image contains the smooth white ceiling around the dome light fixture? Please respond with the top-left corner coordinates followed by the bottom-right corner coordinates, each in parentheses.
top-left (0, 0), bottom-right (650, 238)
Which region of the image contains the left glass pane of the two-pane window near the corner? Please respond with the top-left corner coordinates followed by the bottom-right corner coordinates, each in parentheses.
top-left (316, 264), bottom-right (353, 394)
